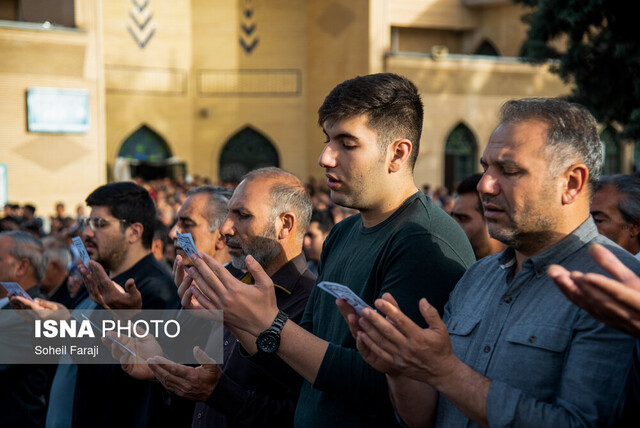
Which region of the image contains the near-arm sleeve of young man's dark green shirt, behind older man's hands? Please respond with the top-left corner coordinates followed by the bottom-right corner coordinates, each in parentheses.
top-left (312, 232), bottom-right (467, 399)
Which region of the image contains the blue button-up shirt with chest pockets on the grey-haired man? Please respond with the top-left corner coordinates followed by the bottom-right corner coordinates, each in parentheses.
top-left (436, 218), bottom-right (640, 428)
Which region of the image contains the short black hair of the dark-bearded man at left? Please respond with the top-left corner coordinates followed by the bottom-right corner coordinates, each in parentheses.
top-left (85, 181), bottom-right (156, 249)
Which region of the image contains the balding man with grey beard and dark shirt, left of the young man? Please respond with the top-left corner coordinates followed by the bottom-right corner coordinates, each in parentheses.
top-left (119, 168), bottom-right (315, 427)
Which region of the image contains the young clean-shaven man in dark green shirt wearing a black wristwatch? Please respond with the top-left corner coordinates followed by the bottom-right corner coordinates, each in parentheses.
top-left (185, 73), bottom-right (475, 427)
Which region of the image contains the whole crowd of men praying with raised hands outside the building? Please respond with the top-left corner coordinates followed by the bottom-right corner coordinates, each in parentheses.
top-left (0, 73), bottom-right (640, 427)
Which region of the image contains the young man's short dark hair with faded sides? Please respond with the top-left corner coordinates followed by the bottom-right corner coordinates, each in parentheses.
top-left (318, 73), bottom-right (424, 170)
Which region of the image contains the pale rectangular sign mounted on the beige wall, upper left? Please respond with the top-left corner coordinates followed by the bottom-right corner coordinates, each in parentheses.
top-left (27, 88), bottom-right (89, 134)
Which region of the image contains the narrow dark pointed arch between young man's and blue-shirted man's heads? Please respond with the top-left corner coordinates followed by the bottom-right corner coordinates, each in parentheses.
top-left (444, 123), bottom-right (478, 193)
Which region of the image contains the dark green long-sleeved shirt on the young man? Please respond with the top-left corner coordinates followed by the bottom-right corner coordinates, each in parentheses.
top-left (295, 192), bottom-right (475, 427)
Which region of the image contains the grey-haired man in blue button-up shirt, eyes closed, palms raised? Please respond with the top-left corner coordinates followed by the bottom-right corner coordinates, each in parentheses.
top-left (349, 98), bottom-right (640, 427)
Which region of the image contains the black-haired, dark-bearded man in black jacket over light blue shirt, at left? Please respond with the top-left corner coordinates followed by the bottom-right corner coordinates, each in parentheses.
top-left (47, 182), bottom-right (179, 427)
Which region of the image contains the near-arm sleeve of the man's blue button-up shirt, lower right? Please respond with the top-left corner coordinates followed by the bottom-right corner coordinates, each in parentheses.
top-left (487, 310), bottom-right (634, 427)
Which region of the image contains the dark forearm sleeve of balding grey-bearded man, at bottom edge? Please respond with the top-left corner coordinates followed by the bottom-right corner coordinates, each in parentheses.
top-left (207, 374), bottom-right (302, 426)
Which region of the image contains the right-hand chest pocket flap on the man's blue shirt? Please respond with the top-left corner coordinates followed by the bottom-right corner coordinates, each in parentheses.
top-left (505, 324), bottom-right (571, 352)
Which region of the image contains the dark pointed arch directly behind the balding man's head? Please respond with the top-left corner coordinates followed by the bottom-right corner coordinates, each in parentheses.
top-left (218, 125), bottom-right (280, 183)
